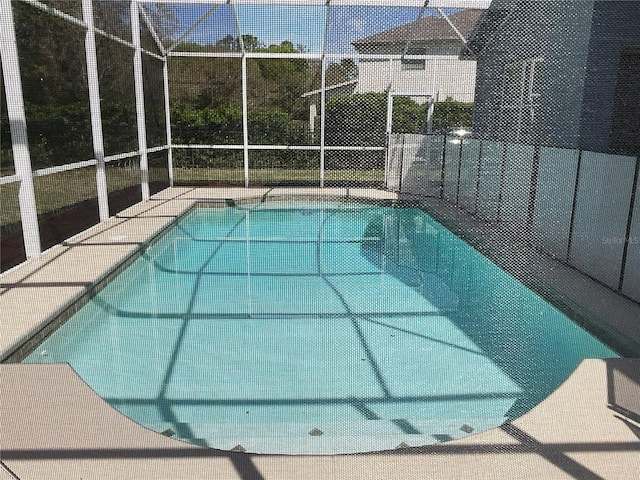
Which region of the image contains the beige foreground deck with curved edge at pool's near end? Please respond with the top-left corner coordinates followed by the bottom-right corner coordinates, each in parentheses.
top-left (0, 359), bottom-right (640, 480)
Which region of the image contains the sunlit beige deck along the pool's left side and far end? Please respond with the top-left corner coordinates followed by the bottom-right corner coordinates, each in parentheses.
top-left (0, 187), bottom-right (397, 363)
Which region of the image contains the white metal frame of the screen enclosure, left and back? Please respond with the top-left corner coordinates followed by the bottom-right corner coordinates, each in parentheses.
top-left (0, 0), bottom-right (491, 266)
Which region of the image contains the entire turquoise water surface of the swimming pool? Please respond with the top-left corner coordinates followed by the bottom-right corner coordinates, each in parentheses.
top-left (25, 202), bottom-right (617, 454)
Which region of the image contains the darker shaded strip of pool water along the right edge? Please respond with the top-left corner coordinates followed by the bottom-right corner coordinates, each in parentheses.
top-left (363, 209), bottom-right (617, 418)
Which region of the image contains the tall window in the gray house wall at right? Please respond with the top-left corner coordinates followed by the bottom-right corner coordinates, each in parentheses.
top-left (500, 58), bottom-right (543, 141)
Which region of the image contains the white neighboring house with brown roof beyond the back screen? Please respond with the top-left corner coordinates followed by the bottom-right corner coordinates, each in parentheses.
top-left (353, 9), bottom-right (483, 102)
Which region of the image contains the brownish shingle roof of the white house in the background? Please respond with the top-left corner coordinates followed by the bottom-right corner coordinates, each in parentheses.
top-left (353, 8), bottom-right (484, 49)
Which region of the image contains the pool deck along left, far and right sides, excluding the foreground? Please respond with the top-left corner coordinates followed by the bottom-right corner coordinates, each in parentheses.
top-left (0, 188), bottom-right (640, 362)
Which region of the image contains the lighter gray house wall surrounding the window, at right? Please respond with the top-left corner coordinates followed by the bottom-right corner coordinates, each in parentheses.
top-left (474, 0), bottom-right (593, 147)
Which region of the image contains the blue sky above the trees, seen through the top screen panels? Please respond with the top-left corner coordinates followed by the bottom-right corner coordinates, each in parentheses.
top-left (170, 4), bottom-right (450, 53)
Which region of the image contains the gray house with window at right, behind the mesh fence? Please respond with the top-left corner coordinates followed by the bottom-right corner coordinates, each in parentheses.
top-left (461, 0), bottom-right (640, 154)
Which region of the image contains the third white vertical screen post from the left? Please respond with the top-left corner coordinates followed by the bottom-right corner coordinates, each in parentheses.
top-left (131, 0), bottom-right (150, 201)
